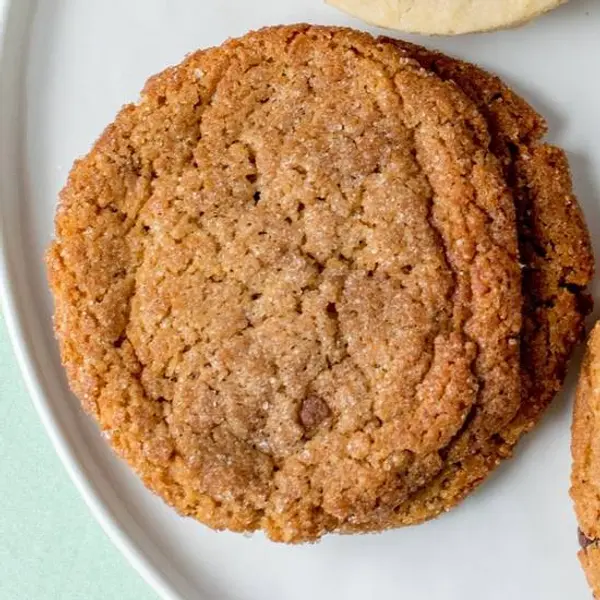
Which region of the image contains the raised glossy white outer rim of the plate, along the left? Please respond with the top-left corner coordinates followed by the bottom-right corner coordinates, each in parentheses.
top-left (0, 0), bottom-right (186, 600)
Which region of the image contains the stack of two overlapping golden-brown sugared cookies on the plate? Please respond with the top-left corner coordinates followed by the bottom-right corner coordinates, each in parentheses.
top-left (48, 25), bottom-right (593, 542)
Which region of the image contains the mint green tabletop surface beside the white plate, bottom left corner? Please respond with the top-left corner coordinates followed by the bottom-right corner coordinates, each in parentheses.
top-left (0, 315), bottom-right (157, 600)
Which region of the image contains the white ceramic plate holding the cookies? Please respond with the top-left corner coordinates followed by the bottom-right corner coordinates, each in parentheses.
top-left (0, 0), bottom-right (600, 600)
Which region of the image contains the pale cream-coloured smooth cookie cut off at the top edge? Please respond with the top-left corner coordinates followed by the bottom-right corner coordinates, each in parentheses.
top-left (326, 0), bottom-right (567, 35)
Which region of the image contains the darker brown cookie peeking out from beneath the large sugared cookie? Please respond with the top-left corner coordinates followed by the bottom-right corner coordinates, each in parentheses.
top-left (384, 38), bottom-right (594, 522)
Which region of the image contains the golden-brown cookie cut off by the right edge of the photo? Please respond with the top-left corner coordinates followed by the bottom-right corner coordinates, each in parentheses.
top-left (571, 324), bottom-right (600, 598)
